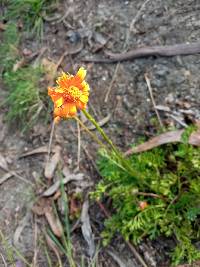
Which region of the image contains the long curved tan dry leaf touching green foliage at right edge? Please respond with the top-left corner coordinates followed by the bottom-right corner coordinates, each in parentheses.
top-left (124, 130), bottom-right (200, 156)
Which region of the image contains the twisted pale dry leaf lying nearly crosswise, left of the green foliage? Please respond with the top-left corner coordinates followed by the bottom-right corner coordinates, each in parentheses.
top-left (42, 173), bottom-right (84, 197)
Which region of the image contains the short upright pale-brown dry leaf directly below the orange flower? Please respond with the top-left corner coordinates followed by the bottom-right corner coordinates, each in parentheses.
top-left (44, 146), bottom-right (61, 179)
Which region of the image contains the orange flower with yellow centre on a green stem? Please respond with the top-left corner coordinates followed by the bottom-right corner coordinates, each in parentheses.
top-left (48, 67), bottom-right (90, 122)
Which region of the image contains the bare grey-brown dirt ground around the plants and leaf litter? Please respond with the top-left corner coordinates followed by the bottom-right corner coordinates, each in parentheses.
top-left (0, 0), bottom-right (200, 267)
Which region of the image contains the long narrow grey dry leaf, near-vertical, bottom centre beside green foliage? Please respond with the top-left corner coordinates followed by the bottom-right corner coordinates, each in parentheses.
top-left (81, 200), bottom-right (95, 258)
